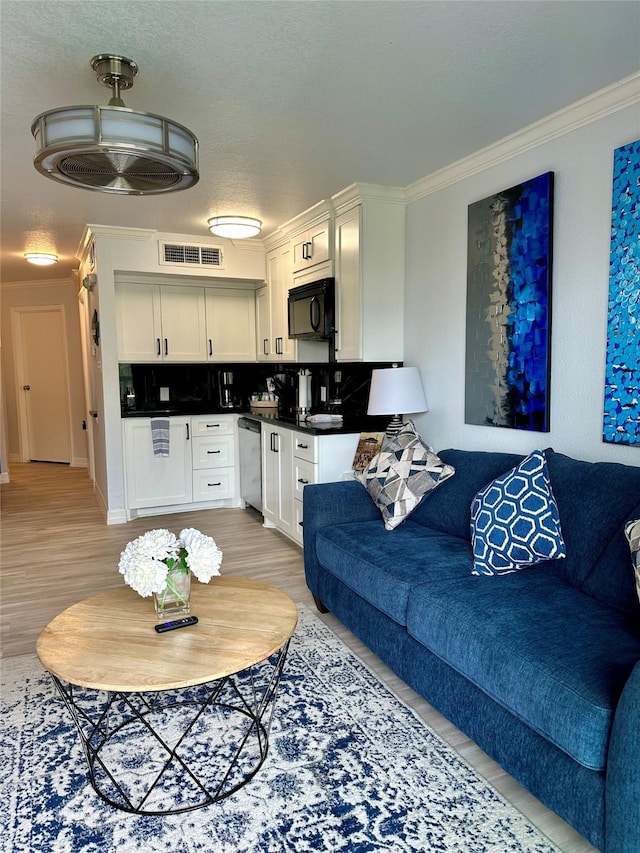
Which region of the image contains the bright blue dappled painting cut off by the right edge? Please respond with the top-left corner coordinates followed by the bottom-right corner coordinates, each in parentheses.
top-left (603, 141), bottom-right (640, 444)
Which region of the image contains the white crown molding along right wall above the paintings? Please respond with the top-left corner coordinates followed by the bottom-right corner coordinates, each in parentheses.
top-left (406, 73), bottom-right (640, 203)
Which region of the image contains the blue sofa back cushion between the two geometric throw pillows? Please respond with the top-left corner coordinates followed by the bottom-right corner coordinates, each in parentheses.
top-left (411, 450), bottom-right (523, 539)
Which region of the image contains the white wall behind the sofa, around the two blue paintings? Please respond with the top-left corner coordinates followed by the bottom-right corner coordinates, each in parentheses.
top-left (405, 104), bottom-right (640, 472)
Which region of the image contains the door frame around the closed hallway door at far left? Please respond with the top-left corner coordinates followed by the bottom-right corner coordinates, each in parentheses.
top-left (11, 305), bottom-right (73, 464)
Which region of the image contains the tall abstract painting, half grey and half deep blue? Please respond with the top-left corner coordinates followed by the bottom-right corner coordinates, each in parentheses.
top-left (465, 172), bottom-right (553, 432)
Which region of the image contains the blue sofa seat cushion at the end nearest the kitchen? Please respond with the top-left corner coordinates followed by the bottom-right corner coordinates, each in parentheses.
top-left (316, 520), bottom-right (473, 625)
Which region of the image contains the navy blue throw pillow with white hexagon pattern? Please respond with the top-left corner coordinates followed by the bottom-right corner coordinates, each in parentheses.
top-left (471, 450), bottom-right (566, 575)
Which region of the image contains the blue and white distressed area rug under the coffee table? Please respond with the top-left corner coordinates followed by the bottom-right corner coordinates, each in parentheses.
top-left (0, 607), bottom-right (558, 853)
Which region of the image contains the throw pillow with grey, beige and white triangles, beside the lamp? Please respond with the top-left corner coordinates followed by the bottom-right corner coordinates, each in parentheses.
top-left (359, 421), bottom-right (455, 530)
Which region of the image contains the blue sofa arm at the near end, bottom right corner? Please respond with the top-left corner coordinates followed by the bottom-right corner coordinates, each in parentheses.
top-left (604, 661), bottom-right (640, 853)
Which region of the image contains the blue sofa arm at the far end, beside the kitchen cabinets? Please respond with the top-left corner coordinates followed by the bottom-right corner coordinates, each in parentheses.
top-left (302, 480), bottom-right (382, 597)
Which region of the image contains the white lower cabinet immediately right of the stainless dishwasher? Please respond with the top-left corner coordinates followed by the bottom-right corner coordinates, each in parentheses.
top-left (262, 423), bottom-right (294, 536)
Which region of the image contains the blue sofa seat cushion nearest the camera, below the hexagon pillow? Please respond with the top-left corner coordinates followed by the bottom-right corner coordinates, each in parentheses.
top-left (407, 564), bottom-right (640, 770)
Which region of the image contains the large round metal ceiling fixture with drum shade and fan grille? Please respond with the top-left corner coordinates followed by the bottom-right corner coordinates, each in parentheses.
top-left (31, 53), bottom-right (200, 195)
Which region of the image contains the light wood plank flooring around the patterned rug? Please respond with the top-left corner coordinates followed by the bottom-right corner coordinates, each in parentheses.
top-left (0, 462), bottom-right (595, 853)
